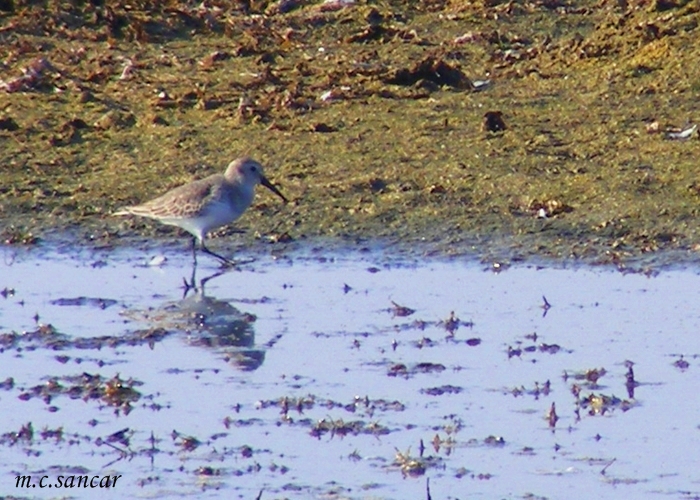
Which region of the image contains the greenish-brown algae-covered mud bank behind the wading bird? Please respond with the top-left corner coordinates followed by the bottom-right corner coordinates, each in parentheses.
top-left (0, 0), bottom-right (700, 264)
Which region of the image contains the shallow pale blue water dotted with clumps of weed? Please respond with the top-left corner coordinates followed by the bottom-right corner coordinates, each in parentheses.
top-left (0, 244), bottom-right (700, 500)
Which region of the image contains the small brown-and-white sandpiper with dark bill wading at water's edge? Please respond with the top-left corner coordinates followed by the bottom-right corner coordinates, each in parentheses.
top-left (114, 157), bottom-right (287, 265)
